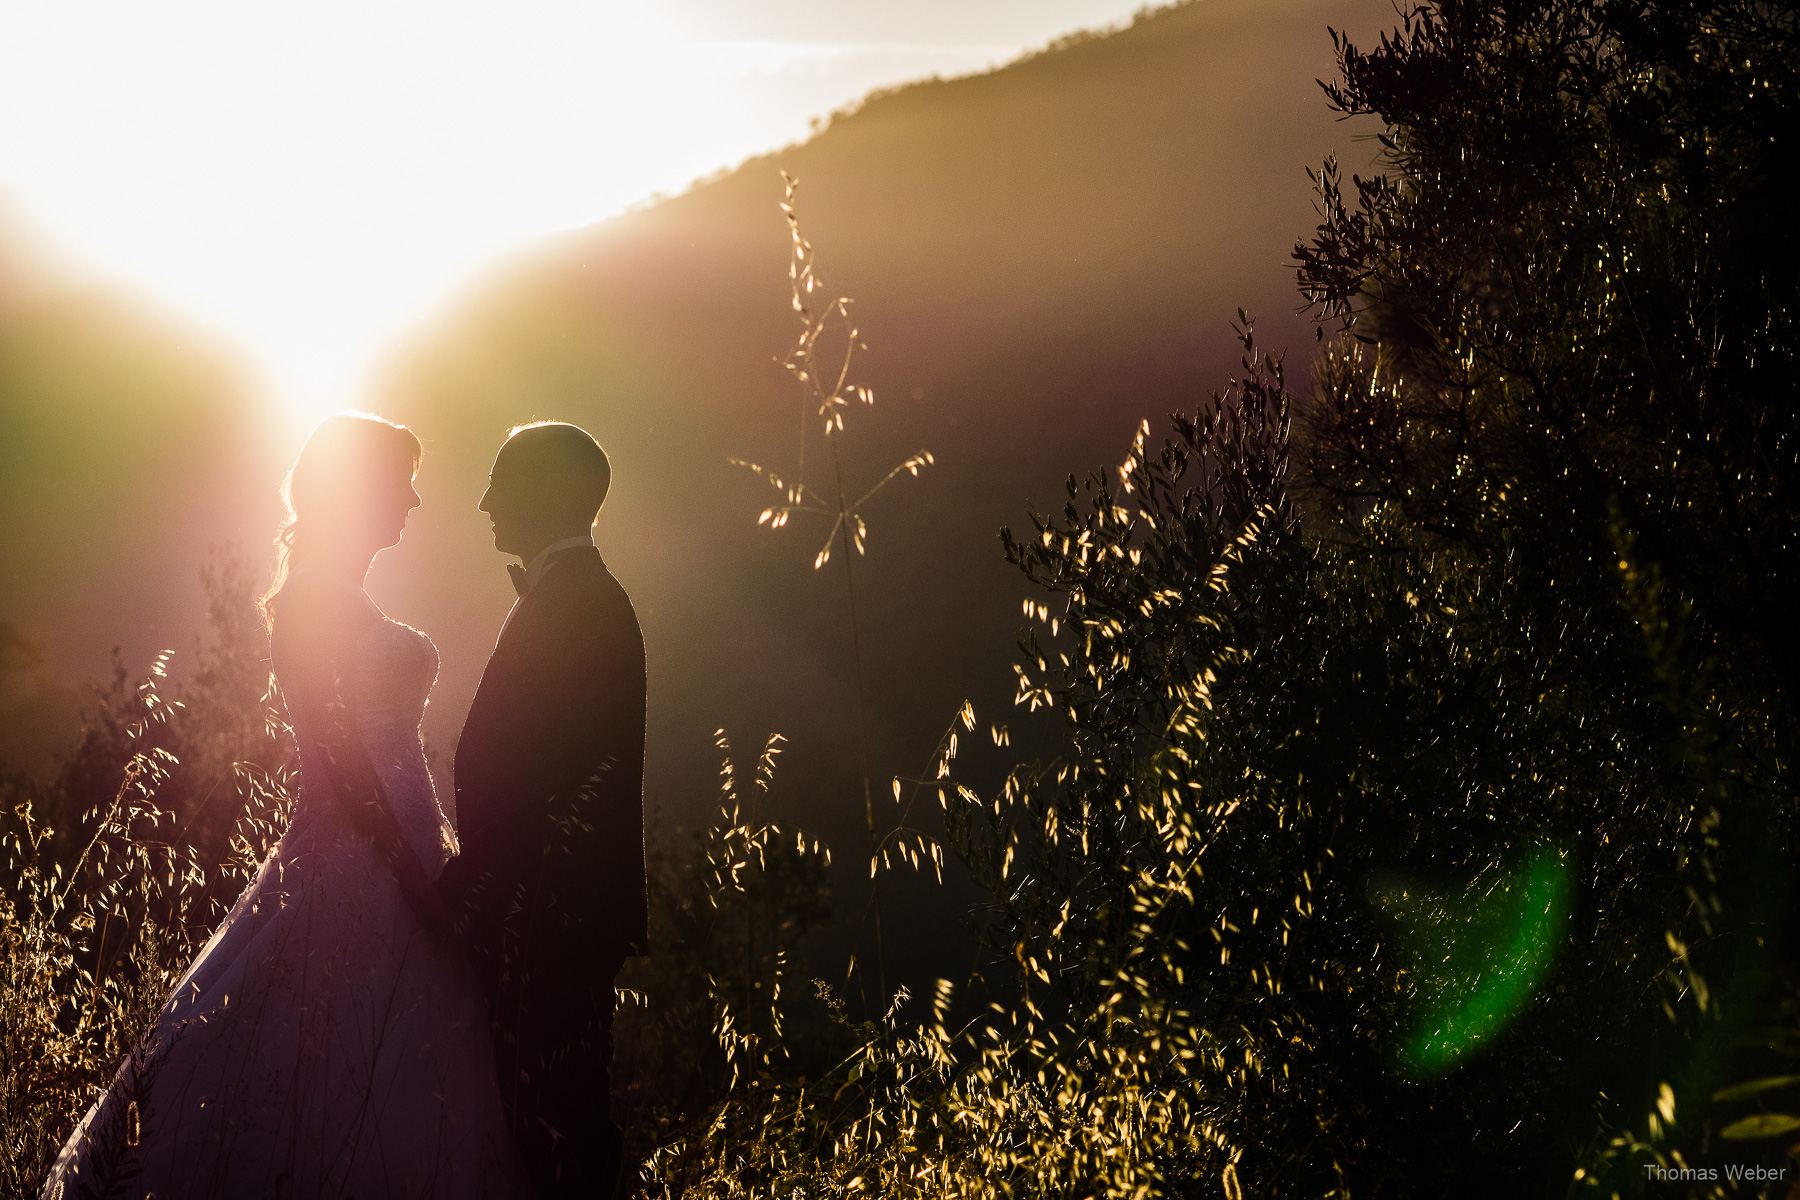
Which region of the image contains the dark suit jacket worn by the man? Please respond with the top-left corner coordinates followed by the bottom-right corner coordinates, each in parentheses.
top-left (439, 547), bottom-right (646, 986)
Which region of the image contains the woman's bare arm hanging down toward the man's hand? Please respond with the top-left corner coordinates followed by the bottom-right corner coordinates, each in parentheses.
top-left (270, 594), bottom-right (450, 934)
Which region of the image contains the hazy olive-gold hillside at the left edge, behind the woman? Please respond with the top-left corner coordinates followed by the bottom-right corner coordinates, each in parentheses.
top-left (0, 212), bottom-right (281, 719)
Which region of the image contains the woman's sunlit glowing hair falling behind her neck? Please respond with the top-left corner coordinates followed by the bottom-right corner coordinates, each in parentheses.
top-left (259, 410), bottom-right (425, 622)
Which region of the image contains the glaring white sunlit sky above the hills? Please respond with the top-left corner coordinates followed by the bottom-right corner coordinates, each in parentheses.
top-left (0, 0), bottom-right (1138, 431)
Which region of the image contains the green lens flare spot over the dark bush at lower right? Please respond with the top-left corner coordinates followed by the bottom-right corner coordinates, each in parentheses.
top-left (1370, 846), bottom-right (1575, 1079)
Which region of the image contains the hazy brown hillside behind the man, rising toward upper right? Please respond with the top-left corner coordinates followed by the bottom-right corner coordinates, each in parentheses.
top-left (382, 0), bottom-right (1393, 978)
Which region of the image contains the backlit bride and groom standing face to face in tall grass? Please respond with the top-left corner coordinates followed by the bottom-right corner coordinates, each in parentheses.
top-left (45, 414), bottom-right (644, 1200)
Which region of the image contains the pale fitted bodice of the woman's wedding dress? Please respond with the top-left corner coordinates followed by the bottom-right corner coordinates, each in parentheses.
top-left (293, 599), bottom-right (455, 878)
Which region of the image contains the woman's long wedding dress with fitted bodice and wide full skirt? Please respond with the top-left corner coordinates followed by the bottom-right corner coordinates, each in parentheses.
top-left (43, 592), bottom-right (527, 1200)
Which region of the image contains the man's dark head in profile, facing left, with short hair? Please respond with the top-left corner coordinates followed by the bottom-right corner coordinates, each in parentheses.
top-left (481, 421), bottom-right (612, 558)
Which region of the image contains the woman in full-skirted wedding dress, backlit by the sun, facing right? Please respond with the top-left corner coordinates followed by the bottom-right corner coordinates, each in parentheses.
top-left (43, 414), bottom-right (527, 1200)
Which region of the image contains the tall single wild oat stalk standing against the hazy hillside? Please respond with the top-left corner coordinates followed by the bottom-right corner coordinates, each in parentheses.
top-left (731, 171), bottom-right (932, 1004)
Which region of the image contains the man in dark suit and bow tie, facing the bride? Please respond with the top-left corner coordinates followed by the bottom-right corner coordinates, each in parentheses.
top-left (439, 421), bottom-right (644, 1198)
